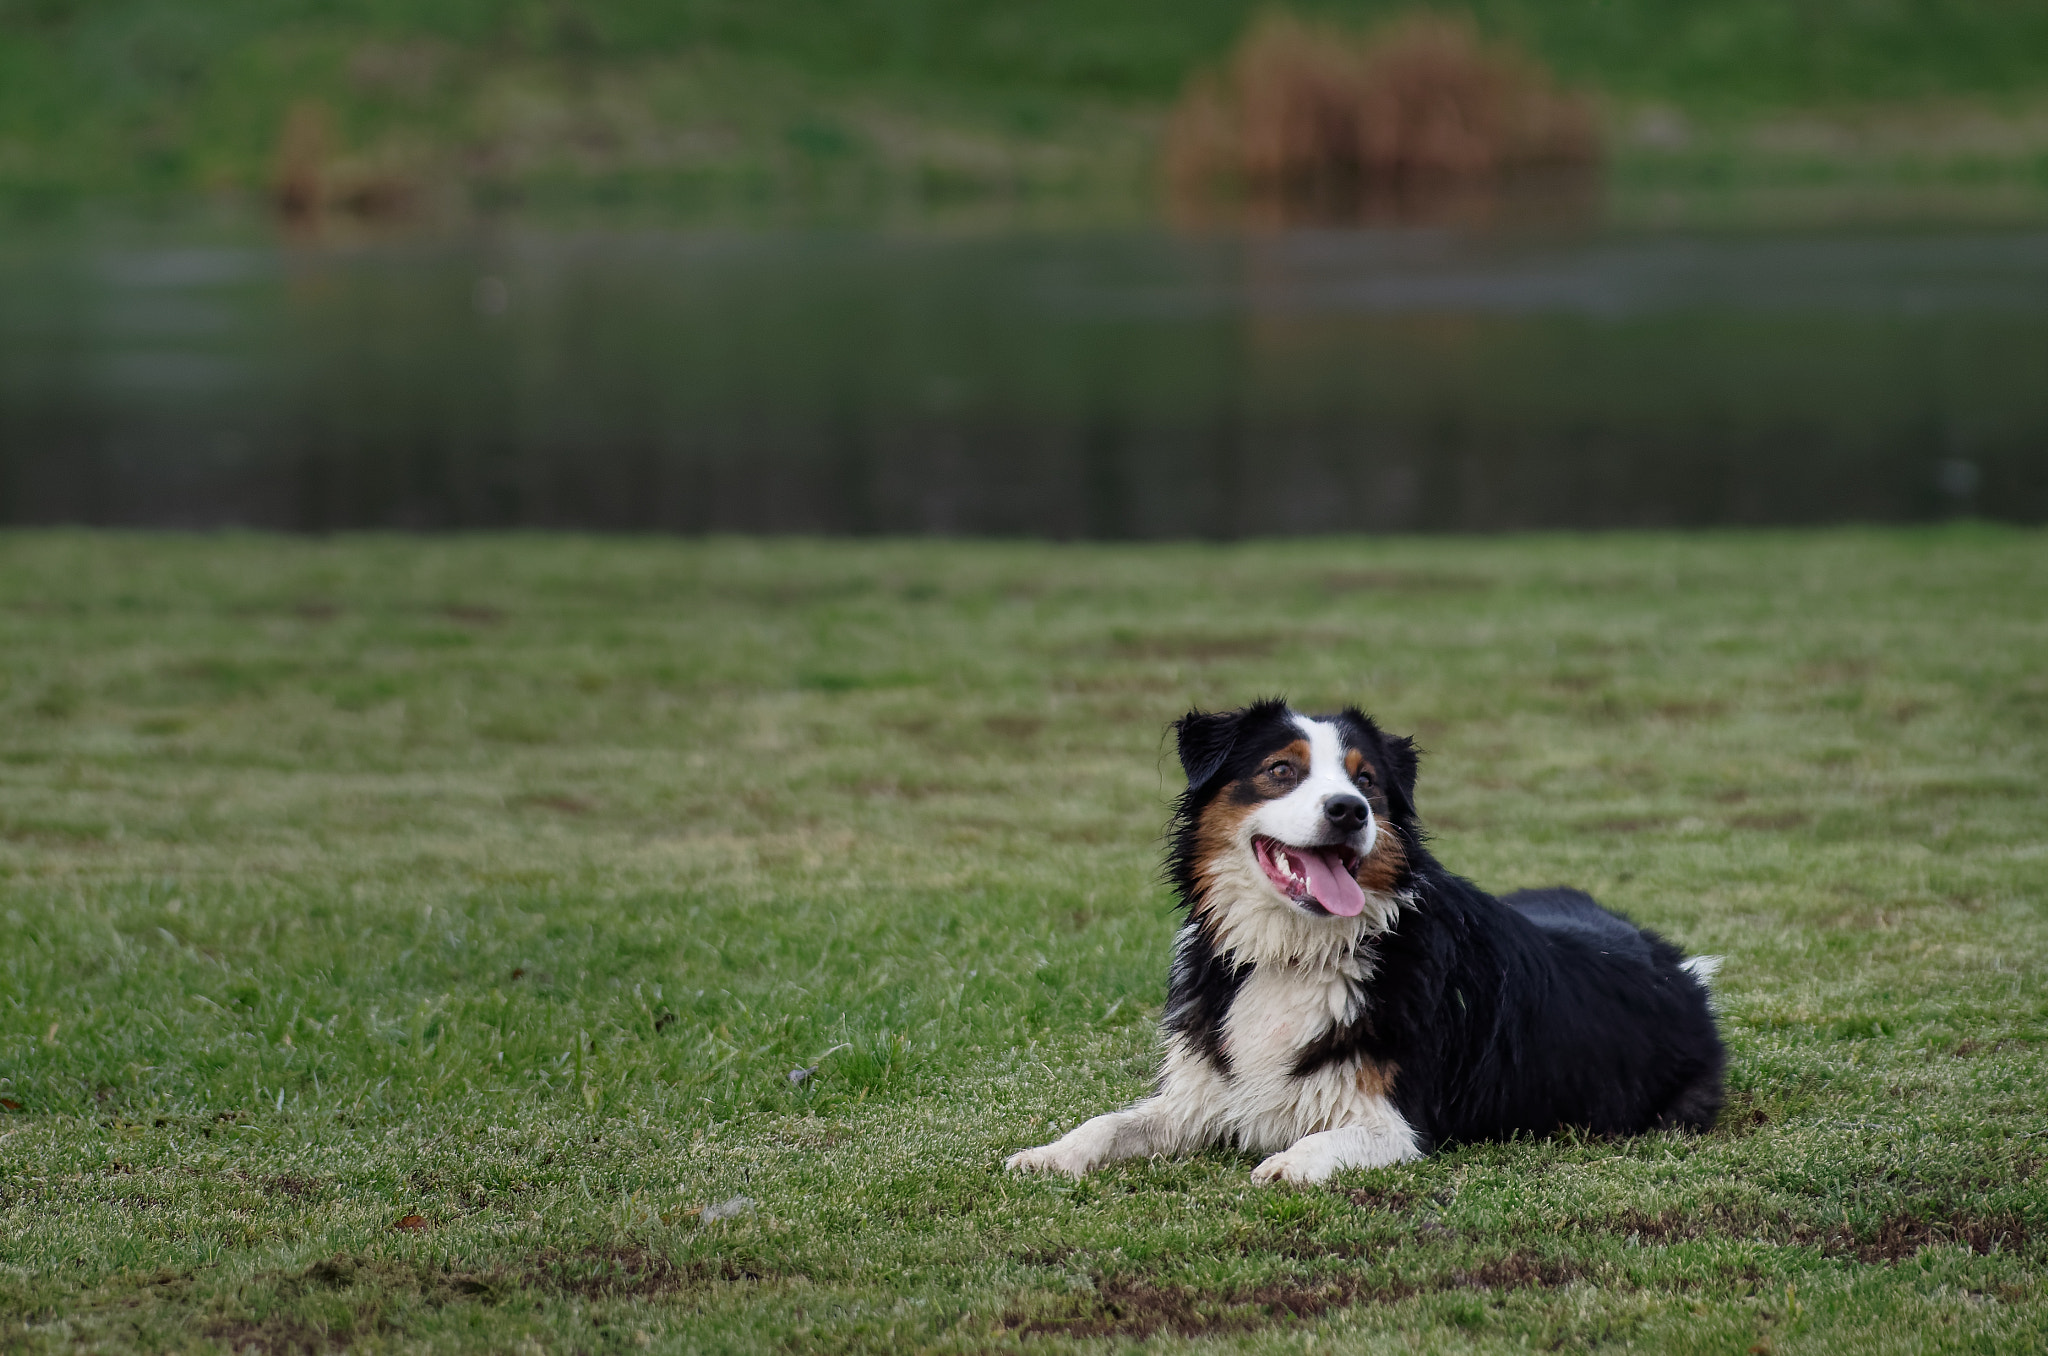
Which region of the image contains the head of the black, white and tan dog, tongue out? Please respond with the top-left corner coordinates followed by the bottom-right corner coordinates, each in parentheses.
top-left (1169, 701), bottom-right (1417, 934)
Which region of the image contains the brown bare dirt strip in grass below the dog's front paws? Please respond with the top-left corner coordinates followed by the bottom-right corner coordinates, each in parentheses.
top-left (1004, 1252), bottom-right (1585, 1338)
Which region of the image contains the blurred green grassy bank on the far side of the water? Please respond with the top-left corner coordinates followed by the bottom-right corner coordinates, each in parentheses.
top-left (0, 0), bottom-right (2048, 210)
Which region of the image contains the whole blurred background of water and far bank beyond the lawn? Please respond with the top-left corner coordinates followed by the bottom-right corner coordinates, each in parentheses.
top-left (0, 0), bottom-right (2048, 539)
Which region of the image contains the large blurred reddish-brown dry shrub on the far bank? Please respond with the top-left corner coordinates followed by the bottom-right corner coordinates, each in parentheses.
top-left (1165, 14), bottom-right (1599, 197)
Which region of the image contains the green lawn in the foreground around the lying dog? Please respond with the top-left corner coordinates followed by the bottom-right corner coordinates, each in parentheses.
top-left (0, 528), bottom-right (2048, 1354)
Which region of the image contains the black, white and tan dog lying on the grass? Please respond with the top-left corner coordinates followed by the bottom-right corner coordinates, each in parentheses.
top-left (1008, 701), bottom-right (1726, 1182)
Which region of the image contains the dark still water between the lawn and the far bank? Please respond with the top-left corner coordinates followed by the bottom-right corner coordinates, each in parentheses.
top-left (0, 229), bottom-right (2048, 537)
